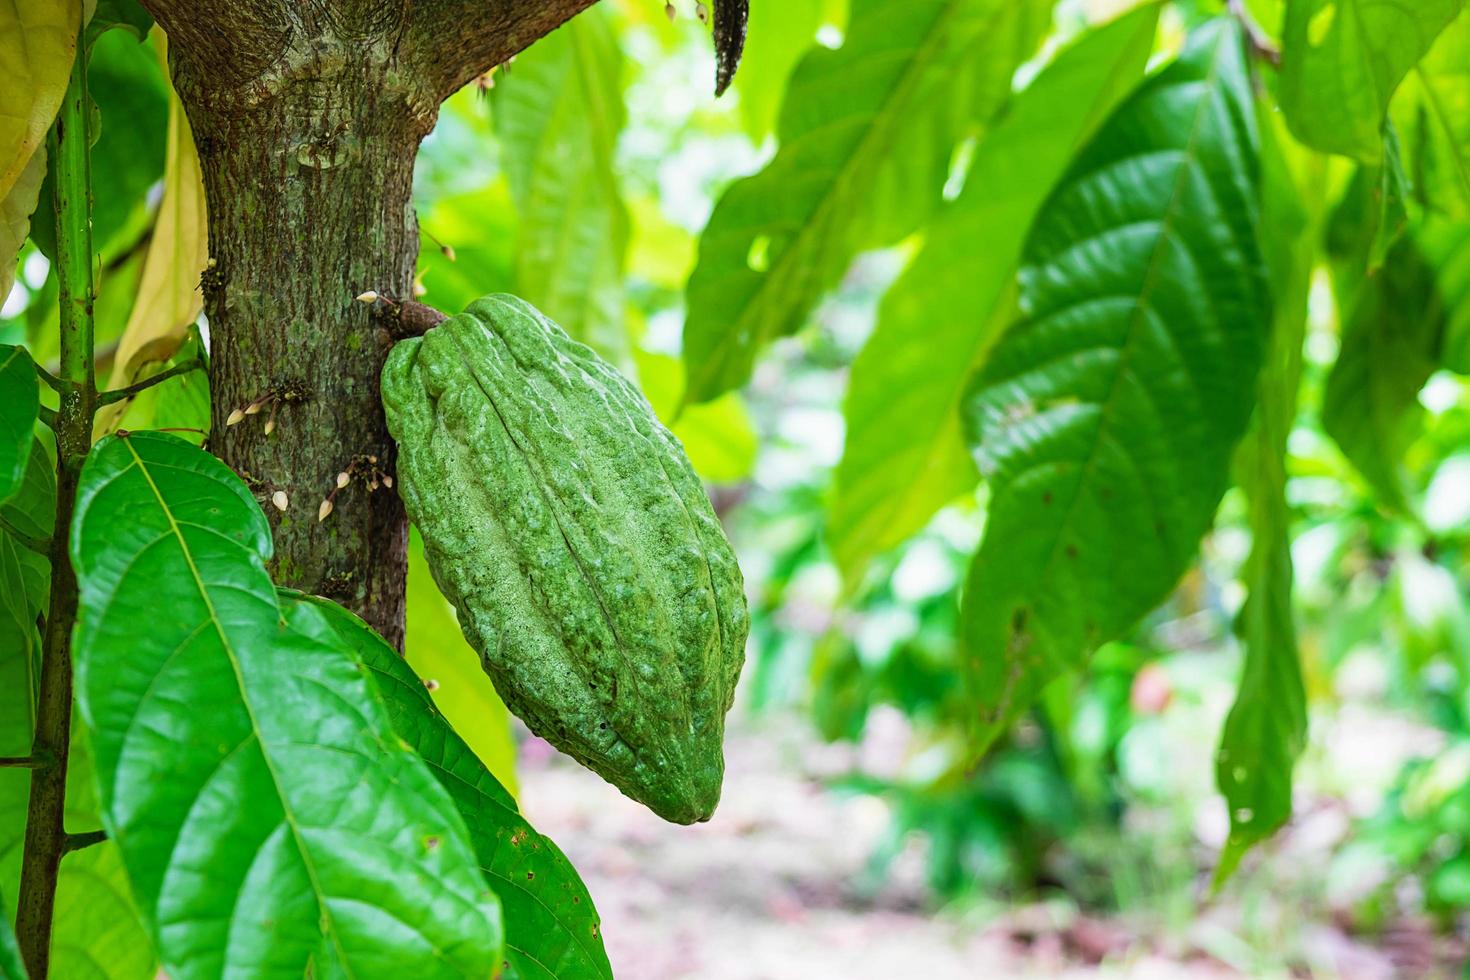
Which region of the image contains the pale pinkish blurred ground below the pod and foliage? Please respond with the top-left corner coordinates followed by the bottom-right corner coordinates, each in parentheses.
top-left (520, 713), bottom-right (1449, 980)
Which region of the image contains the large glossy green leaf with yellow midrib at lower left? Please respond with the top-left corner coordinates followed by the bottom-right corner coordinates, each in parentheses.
top-left (71, 432), bottom-right (501, 977)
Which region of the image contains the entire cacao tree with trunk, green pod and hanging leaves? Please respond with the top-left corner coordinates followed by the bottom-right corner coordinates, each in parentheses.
top-left (0, 0), bottom-right (1470, 980)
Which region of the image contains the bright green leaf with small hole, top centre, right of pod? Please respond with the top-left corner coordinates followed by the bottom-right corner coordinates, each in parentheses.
top-left (684, 0), bottom-right (1051, 403)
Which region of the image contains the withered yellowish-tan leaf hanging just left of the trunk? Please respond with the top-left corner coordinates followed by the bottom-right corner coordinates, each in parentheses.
top-left (97, 34), bottom-right (209, 432)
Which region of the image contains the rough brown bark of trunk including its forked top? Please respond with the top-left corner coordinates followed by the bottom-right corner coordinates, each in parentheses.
top-left (144, 0), bottom-right (594, 646)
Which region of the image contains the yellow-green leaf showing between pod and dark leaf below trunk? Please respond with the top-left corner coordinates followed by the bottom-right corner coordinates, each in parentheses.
top-left (403, 532), bottom-right (516, 795)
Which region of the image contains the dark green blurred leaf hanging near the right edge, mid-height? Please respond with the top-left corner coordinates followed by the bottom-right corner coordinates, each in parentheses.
top-left (1322, 238), bottom-right (1446, 514)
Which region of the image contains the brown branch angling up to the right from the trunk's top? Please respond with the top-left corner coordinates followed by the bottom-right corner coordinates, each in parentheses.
top-left (409, 0), bottom-right (597, 100)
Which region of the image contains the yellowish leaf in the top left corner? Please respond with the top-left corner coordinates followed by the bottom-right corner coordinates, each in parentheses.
top-left (0, 0), bottom-right (82, 200)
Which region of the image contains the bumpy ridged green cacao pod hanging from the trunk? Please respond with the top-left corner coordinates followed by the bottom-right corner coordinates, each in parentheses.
top-left (382, 295), bottom-right (750, 823)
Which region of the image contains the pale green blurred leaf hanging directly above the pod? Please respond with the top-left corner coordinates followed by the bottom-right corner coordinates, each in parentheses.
top-left (496, 7), bottom-right (628, 363)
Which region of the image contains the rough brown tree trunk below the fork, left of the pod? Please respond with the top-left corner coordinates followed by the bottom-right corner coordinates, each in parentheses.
top-left (176, 44), bottom-right (437, 648)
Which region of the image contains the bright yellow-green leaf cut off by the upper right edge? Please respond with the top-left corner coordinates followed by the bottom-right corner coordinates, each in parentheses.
top-left (1394, 12), bottom-right (1470, 219)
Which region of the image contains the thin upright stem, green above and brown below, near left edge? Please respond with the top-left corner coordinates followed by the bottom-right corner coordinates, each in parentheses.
top-left (15, 38), bottom-right (97, 980)
